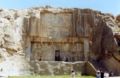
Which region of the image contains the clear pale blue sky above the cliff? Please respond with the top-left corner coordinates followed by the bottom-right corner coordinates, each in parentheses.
top-left (0, 0), bottom-right (120, 15)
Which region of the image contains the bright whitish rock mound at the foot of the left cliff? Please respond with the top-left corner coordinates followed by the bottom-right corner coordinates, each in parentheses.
top-left (0, 52), bottom-right (31, 76)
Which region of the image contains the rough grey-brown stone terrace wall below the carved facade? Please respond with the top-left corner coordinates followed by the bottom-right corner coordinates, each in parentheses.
top-left (32, 61), bottom-right (86, 75)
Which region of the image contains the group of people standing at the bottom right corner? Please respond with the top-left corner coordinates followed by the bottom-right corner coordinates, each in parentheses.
top-left (96, 70), bottom-right (113, 78)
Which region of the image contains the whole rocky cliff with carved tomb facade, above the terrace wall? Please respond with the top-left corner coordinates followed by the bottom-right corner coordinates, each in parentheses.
top-left (0, 8), bottom-right (120, 75)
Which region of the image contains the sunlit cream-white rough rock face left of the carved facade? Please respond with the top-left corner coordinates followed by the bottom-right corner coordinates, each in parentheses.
top-left (0, 9), bottom-right (30, 76)
